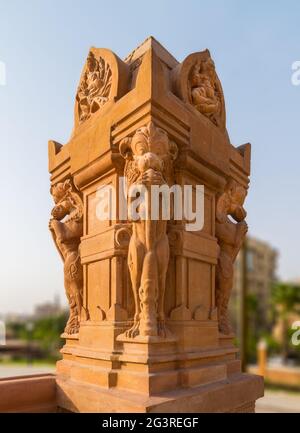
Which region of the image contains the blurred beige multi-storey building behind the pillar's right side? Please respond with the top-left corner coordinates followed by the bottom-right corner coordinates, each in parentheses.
top-left (230, 236), bottom-right (278, 337)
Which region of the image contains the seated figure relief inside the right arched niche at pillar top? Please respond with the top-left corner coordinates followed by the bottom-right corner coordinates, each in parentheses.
top-left (189, 57), bottom-right (222, 126)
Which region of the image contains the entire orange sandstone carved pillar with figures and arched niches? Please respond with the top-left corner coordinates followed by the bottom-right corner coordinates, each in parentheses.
top-left (49, 38), bottom-right (263, 412)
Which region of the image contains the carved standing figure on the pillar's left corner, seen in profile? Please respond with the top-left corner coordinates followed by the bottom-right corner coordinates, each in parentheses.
top-left (49, 180), bottom-right (83, 334)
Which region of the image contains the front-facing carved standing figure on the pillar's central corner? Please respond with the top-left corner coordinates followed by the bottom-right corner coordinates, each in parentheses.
top-left (120, 122), bottom-right (177, 338)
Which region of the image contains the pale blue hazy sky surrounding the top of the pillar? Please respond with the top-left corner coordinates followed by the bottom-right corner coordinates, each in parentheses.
top-left (0, 0), bottom-right (300, 314)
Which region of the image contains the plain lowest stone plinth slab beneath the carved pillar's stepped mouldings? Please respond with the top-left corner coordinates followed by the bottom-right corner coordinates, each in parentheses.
top-left (57, 374), bottom-right (263, 413)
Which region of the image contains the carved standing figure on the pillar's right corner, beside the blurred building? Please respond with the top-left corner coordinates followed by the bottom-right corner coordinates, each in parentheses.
top-left (216, 180), bottom-right (248, 335)
